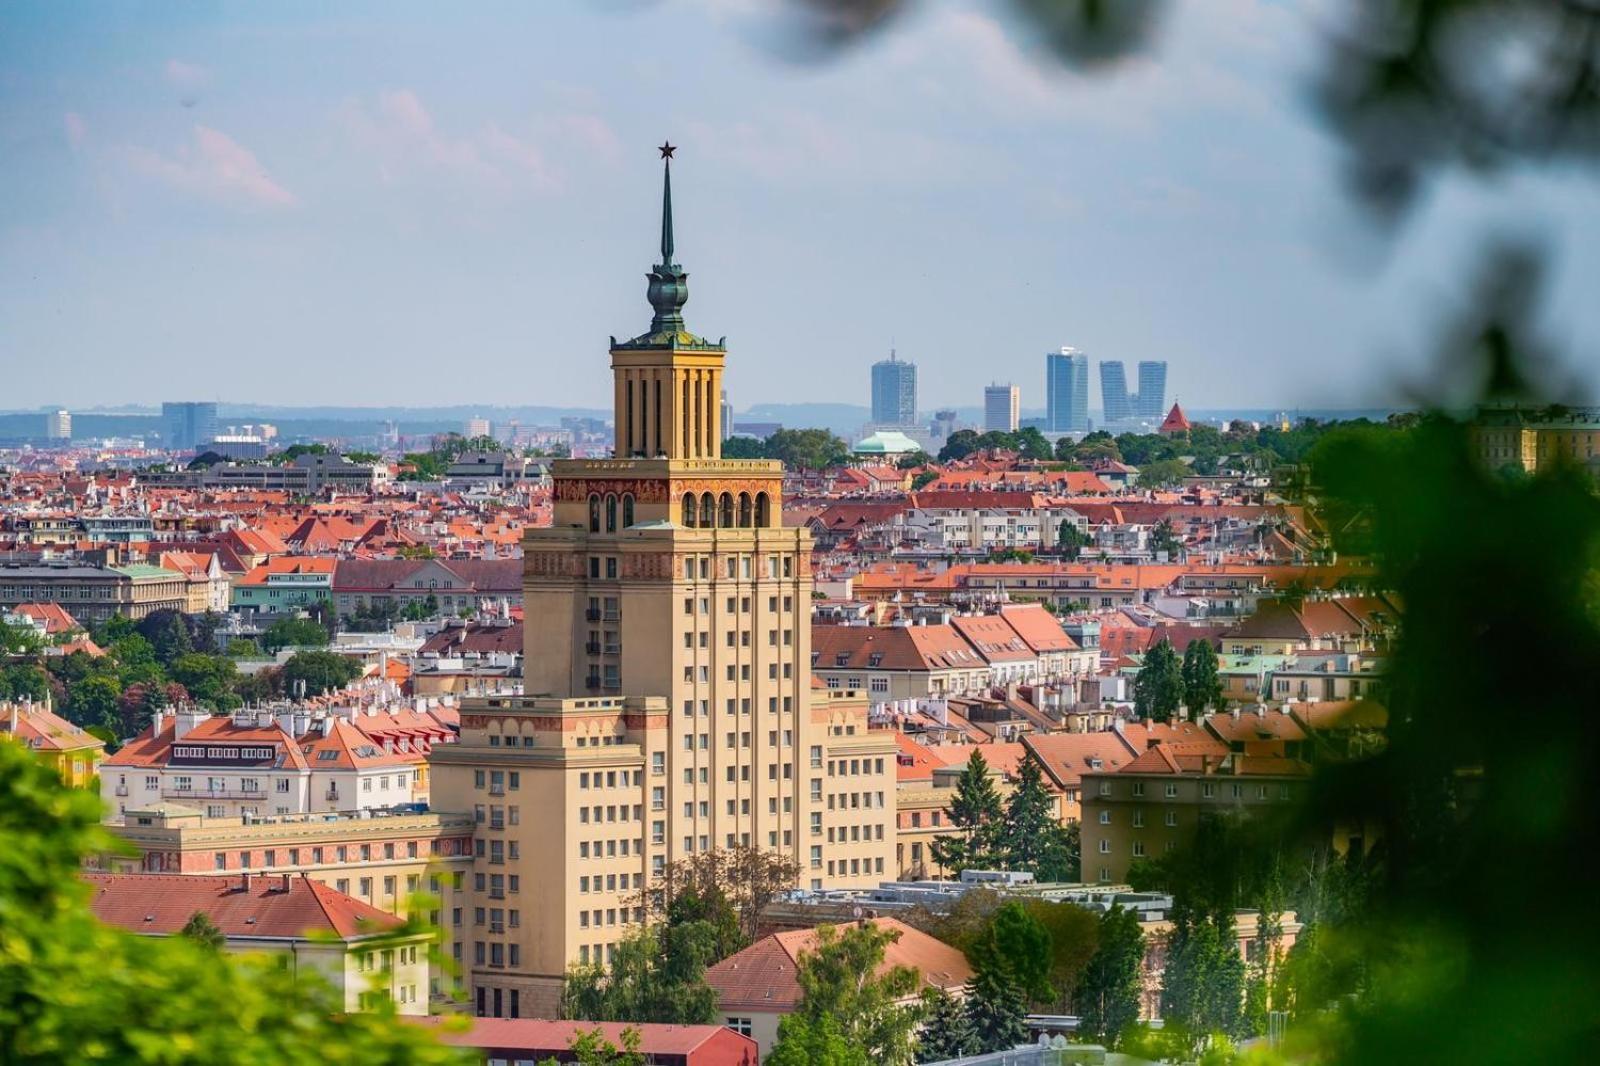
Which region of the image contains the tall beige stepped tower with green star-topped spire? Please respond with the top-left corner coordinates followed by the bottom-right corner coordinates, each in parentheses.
top-left (430, 149), bottom-right (896, 1018)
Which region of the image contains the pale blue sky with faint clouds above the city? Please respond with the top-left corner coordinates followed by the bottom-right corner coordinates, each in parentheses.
top-left (0, 0), bottom-right (1600, 410)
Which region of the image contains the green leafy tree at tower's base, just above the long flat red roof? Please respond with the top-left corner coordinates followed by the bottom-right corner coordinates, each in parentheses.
top-left (562, 922), bottom-right (717, 1024)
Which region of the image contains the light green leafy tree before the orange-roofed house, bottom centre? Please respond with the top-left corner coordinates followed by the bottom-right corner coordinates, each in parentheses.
top-left (774, 922), bottom-right (922, 1063)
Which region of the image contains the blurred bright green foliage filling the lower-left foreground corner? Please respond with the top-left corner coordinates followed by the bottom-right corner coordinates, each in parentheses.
top-left (0, 744), bottom-right (474, 1066)
